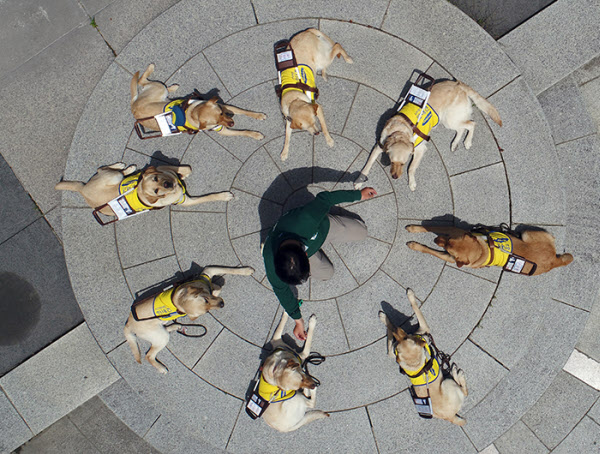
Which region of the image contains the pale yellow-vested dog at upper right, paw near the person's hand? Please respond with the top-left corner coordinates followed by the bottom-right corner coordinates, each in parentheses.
top-left (354, 81), bottom-right (502, 191)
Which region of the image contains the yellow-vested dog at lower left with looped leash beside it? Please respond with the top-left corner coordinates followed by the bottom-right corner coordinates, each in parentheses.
top-left (123, 266), bottom-right (254, 374)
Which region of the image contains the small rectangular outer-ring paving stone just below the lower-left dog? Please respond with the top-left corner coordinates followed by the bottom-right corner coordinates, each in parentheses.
top-left (98, 378), bottom-right (160, 437)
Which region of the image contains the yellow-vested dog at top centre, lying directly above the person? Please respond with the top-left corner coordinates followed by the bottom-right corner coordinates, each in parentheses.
top-left (281, 28), bottom-right (353, 161)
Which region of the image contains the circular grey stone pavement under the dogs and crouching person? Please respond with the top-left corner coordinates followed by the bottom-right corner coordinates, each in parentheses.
top-left (58, 0), bottom-right (583, 453)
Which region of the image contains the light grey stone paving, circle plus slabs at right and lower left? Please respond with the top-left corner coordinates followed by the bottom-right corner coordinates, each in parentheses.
top-left (0, 0), bottom-right (600, 453)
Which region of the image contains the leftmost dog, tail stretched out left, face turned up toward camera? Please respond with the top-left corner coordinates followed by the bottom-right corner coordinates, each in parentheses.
top-left (54, 162), bottom-right (233, 216)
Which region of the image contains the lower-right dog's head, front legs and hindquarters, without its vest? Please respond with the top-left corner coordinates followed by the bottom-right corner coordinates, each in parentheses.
top-left (379, 289), bottom-right (469, 426)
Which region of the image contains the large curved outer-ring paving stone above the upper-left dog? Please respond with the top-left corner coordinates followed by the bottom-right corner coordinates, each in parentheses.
top-left (117, 0), bottom-right (256, 80)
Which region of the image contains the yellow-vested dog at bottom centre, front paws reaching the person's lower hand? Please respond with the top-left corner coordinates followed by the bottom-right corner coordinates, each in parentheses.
top-left (259, 312), bottom-right (329, 432)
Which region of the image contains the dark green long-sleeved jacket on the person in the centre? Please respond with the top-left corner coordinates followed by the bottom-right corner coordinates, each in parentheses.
top-left (263, 191), bottom-right (361, 320)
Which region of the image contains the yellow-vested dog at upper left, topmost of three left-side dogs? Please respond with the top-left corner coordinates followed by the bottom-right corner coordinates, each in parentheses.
top-left (130, 64), bottom-right (267, 140)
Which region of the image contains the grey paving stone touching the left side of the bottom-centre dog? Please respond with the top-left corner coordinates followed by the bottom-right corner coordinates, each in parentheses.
top-left (192, 329), bottom-right (261, 400)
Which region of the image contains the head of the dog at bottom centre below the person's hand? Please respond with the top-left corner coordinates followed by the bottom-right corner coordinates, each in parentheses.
top-left (263, 350), bottom-right (317, 391)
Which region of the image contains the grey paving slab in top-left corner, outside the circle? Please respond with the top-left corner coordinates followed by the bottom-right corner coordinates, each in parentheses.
top-left (0, 0), bottom-right (89, 77)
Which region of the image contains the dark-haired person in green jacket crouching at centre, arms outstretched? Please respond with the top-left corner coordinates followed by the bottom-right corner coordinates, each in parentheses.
top-left (262, 188), bottom-right (377, 340)
